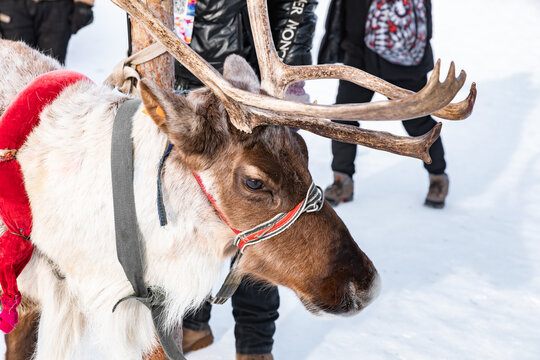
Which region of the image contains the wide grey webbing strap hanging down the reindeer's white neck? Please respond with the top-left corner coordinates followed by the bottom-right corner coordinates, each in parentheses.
top-left (111, 99), bottom-right (186, 360)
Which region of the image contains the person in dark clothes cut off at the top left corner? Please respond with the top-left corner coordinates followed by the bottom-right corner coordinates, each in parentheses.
top-left (0, 0), bottom-right (94, 64)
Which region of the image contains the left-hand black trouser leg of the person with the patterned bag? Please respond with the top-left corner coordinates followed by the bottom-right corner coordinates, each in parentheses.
top-left (332, 81), bottom-right (373, 177)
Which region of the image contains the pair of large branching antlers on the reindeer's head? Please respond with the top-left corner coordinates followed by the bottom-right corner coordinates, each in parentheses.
top-left (112, 0), bottom-right (476, 162)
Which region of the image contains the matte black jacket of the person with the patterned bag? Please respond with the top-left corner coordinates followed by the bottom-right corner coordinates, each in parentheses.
top-left (318, 0), bottom-right (434, 80)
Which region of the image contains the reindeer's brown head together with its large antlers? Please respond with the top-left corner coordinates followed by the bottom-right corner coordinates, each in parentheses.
top-left (113, 0), bottom-right (476, 314)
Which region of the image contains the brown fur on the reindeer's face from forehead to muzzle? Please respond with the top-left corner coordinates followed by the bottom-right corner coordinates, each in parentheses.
top-left (220, 128), bottom-right (375, 313)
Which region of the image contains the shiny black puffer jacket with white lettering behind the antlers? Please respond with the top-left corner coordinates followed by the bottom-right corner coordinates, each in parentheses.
top-left (175, 0), bottom-right (317, 89)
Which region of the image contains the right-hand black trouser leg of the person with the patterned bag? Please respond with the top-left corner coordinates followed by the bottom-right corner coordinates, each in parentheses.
top-left (390, 76), bottom-right (446, 175)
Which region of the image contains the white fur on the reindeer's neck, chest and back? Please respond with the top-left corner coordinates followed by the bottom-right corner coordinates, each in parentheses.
top-left (0, 41), bottom-right (233, 360)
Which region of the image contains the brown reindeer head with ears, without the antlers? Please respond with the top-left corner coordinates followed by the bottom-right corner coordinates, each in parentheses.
top-left (140, 55), bottom-right (378, 313)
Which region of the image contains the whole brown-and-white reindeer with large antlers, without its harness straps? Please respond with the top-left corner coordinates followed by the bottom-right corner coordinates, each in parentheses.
top-left (0, 0), bottom-right (476, 360)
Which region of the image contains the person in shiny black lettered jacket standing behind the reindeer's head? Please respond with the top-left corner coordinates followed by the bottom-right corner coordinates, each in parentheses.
top-left (144, 0), bottom-right (317, 360)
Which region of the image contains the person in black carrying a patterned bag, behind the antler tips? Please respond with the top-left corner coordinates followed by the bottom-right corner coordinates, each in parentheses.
top-left (318, 0), bottom-right (449, 208)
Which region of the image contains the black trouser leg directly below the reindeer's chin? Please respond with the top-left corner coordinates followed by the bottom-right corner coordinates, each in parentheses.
top-left (232, 279), bottom-right (279, 354)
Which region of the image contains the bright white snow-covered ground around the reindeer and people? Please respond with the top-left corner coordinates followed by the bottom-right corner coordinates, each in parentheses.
top-left (0, 0), bottom-right (540, 360)
